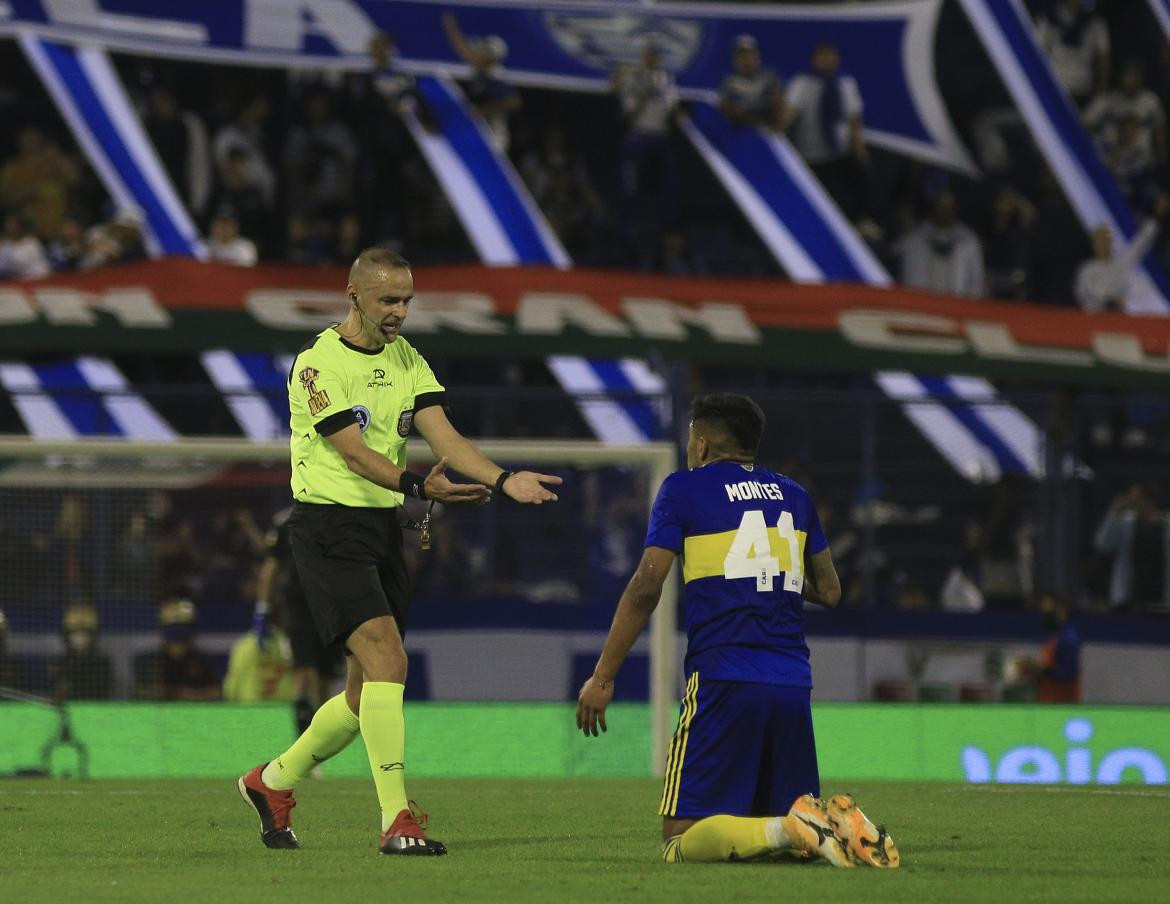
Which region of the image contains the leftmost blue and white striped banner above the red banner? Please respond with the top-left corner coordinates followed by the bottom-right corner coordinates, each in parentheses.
top-left (19, 33), bottom-right (204, 257)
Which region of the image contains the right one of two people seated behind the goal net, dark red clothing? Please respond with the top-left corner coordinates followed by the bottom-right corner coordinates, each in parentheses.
top-left (135, 600), bottom-right (220, 701)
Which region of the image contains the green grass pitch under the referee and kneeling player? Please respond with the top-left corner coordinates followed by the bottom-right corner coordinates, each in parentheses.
top-left (0, 779), bottom-right (1170, 904)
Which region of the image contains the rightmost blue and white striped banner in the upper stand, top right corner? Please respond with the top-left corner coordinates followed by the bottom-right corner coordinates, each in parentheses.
top-left (961, 0), bottom-right (1170, 313)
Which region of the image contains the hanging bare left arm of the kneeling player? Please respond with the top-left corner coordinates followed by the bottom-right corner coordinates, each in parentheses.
top-left (577, 546), bottom-right (675, 738)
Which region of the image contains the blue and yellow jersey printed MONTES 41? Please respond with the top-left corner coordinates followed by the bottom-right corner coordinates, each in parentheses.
top-left (646, 462), bottom-right (828, 688)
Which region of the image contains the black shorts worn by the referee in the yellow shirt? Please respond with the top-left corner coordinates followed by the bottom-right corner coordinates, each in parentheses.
top-left (288, 502), bottom-right (410, 644)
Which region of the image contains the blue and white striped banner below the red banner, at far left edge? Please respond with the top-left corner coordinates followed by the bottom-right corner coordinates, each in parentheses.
top-left (0, 356), bottom-right (178, 440)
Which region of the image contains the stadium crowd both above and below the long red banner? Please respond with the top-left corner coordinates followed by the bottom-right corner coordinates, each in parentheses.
top-left (0, 0), bottom-right (1170, 699)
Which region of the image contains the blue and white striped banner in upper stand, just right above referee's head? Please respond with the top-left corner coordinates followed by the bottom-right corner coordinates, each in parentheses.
top-left (407, 77), bottom-right (570, 267)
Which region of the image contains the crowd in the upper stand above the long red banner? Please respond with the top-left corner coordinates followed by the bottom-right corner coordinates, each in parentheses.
top-left (0, 0), bottom-right (1170, 310)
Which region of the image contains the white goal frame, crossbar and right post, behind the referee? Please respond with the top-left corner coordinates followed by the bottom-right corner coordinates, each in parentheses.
top-left (0, 436), bottom-right (680, 777)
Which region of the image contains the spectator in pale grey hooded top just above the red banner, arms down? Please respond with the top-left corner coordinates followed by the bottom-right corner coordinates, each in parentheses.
top-left (901, 191), bottom-right (986, 297)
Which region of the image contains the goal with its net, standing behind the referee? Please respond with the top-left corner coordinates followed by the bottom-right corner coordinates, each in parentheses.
top-left (0, 437), bottom-right (681, 774)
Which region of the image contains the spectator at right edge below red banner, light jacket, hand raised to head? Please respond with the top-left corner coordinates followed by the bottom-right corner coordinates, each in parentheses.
top-left (1093, 483), bottom-right (1170, 612)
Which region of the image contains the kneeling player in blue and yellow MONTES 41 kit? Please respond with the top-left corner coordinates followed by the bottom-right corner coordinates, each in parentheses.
top-left (577, 394), bottom-right (899, 867)
